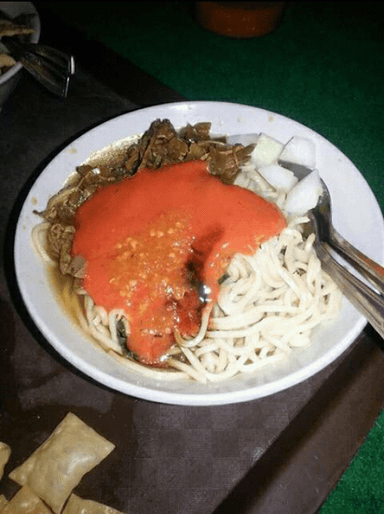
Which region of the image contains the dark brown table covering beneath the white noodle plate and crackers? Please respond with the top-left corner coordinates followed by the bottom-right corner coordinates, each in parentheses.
top-left (0, 61), bottom-right (384, 514)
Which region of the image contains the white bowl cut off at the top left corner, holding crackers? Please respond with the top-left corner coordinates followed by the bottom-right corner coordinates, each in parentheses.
top-left (0, 2), bottom-right (40, 109)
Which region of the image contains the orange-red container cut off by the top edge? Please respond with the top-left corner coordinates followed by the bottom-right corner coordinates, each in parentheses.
top-left (196, 2), bottom-right (287, 38)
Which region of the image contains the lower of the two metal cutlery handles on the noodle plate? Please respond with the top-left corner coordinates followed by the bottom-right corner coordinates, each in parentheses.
top-left (316, 243), bottom-right (384, 338)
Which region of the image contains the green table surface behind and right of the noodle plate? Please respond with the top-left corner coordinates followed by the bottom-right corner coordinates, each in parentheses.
top-left (34, 2), bottom-right (384, 514)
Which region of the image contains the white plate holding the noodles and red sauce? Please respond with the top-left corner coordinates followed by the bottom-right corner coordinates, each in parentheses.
top-left (15, 102), bottom-right (384, 405)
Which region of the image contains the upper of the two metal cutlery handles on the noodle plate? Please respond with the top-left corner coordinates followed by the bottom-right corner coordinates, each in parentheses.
top-left (328, 229), bottom-right (384, 294)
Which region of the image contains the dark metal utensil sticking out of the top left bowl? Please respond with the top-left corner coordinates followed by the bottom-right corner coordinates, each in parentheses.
top-left (1, 37), bottom-right (75, 98)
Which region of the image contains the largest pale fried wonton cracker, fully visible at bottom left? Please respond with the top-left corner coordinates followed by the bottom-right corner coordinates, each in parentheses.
top-left (9, 413), bottom-right (115, 514)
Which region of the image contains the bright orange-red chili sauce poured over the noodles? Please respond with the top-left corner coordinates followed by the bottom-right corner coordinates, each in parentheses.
top-left (72, 160), bottom-right (286, 365)
